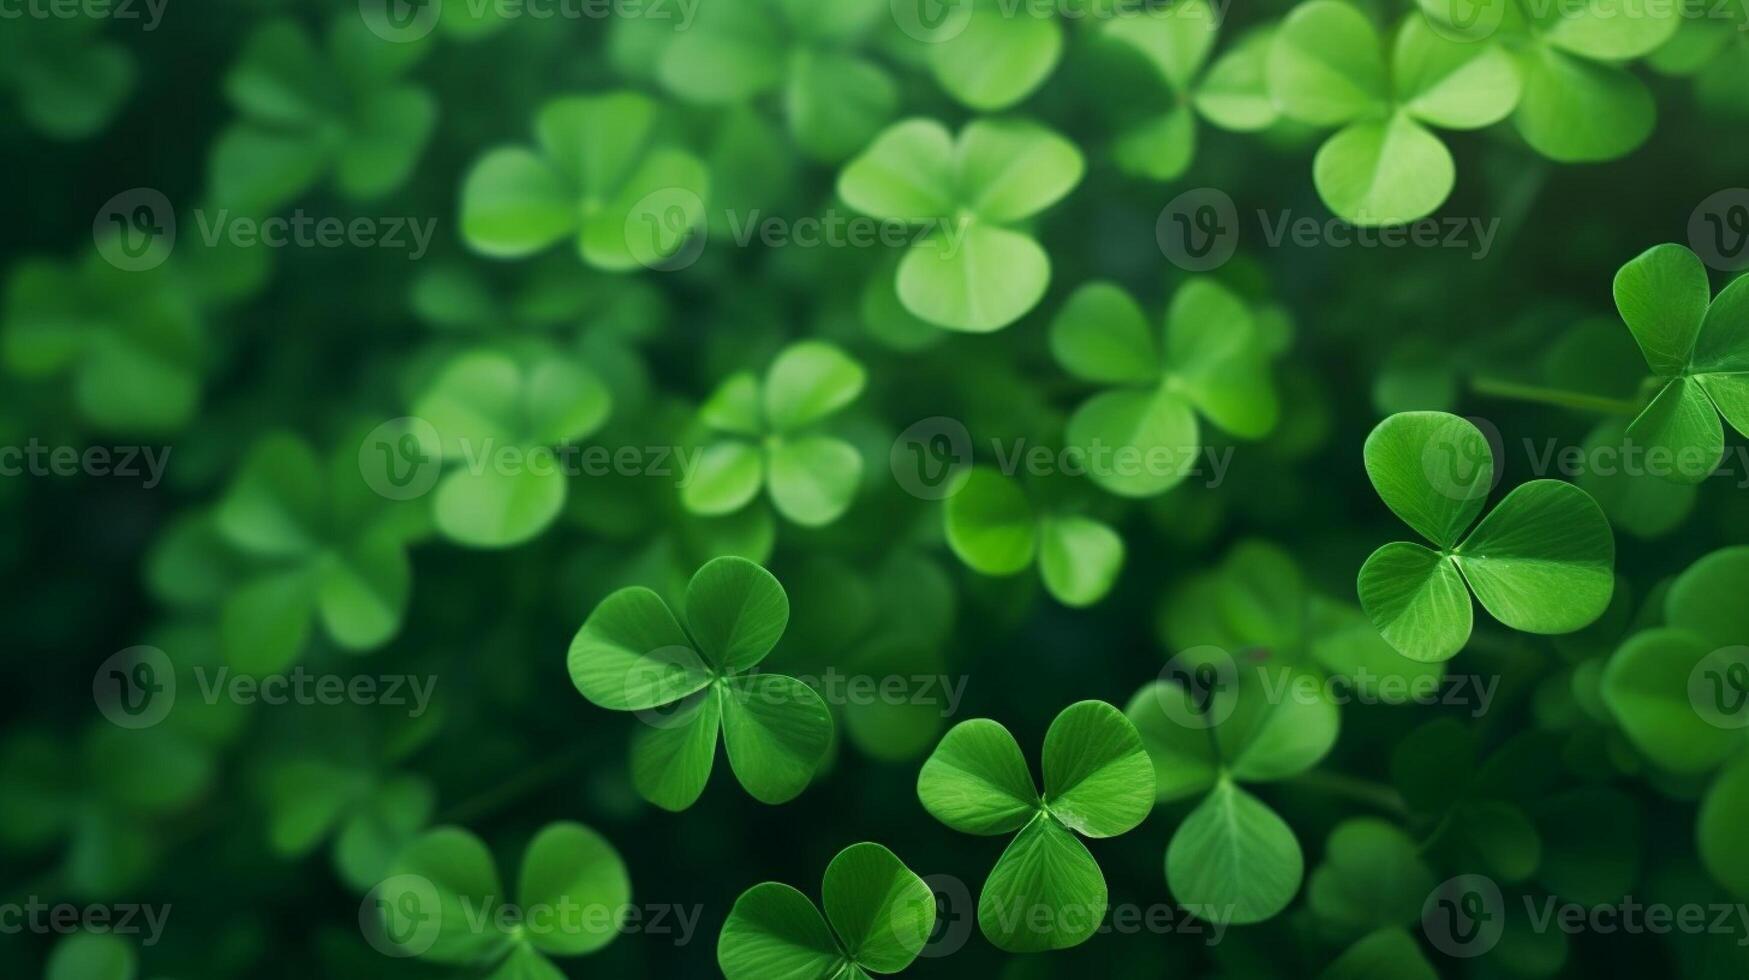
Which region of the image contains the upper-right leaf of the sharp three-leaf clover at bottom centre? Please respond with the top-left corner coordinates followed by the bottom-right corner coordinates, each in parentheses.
top-left (1044, 702), bottom-right (1154, 838)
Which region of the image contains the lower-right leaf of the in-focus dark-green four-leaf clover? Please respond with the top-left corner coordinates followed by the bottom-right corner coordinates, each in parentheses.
top-left (722, 674), bottom-right (833, 807)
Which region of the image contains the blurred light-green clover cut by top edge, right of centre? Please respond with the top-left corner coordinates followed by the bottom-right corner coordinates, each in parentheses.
top-left (1102, 0), bottom-right (1280, 180)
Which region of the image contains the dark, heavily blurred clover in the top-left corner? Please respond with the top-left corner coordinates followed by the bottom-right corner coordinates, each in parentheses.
top-left (0, 12), bottom-right (136, 140)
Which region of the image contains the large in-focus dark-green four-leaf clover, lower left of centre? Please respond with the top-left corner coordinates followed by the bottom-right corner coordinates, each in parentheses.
top-left (567, 558), bottom-right (833, 810)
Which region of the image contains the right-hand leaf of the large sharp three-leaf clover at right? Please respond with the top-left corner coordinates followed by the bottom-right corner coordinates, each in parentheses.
top-left (1453, 480), bottom-right (1616, 634)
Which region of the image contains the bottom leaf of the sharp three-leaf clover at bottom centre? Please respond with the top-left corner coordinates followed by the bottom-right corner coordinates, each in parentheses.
top-left (978, 814), bottom-right (1107, 952)
